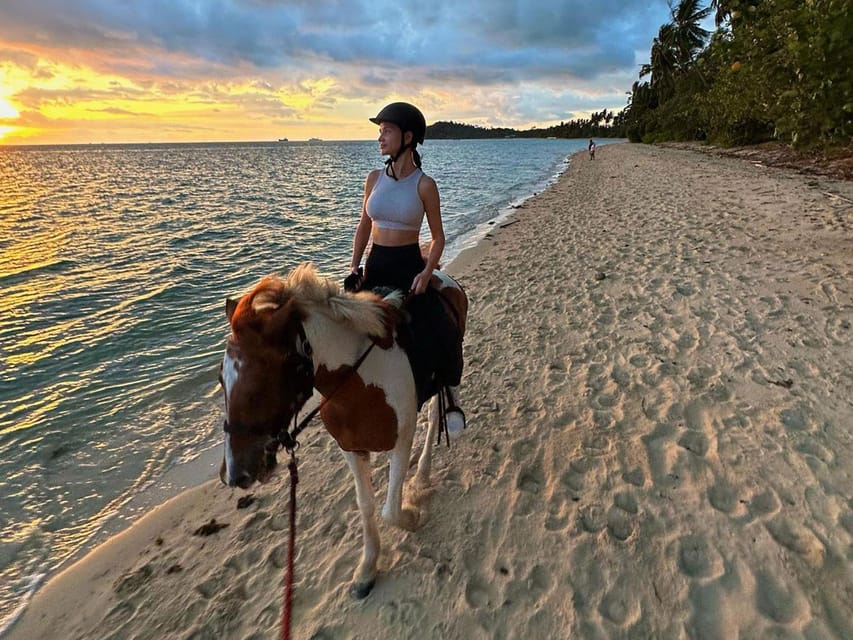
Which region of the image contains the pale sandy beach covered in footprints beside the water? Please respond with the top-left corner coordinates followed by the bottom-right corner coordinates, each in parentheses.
top-left (8, 144), bottom-right (853, 640)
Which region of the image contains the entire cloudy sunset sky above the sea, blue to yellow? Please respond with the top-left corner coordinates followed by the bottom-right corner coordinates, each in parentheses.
top-left (0, 0), bottom-right (669, 144)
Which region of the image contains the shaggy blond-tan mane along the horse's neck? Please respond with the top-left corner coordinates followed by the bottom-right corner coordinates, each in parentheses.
top-left (240, 262), bottom-right (402, 337)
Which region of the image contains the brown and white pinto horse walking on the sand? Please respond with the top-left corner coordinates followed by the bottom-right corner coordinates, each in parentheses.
top-left (220, 264), bottom-right (468, 598)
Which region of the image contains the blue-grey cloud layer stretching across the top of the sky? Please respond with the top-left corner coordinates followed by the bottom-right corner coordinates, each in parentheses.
top-left (0, 0), bottom-right (666, 84)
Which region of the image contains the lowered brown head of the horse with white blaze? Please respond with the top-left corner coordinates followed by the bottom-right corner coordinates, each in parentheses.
top-left (219, 277), bottom-right (314, 489)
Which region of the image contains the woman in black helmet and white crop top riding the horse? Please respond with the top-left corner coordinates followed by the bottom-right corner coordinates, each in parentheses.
top-left (344, 102), bottom-right (462, 407)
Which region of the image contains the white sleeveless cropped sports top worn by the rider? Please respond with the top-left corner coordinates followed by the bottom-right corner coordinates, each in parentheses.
top-left (366, 169), bottom-right (424, 231)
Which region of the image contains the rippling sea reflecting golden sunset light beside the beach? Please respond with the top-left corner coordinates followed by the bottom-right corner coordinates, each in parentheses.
top-left (0, 140), bottom-right (612, 635)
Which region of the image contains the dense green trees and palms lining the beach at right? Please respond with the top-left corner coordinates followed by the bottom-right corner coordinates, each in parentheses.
top-left (620, 0), bottom-right (853, 149)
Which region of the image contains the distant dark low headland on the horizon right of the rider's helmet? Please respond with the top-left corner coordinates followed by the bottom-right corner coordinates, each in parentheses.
top-left (426, 109), bottom-right (625, 140)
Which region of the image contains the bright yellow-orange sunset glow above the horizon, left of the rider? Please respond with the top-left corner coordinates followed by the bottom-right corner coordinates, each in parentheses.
top-left (0, 42), bottom-right (373, 144)
